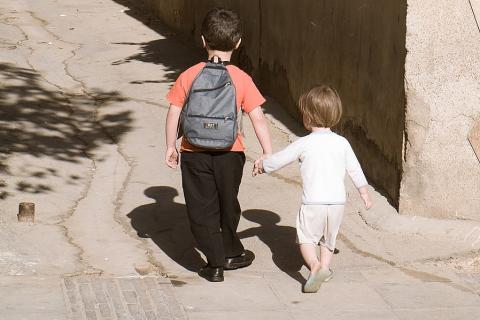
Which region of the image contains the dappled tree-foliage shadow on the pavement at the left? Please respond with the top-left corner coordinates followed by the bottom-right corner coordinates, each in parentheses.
top-left (0, 63), bottom-right (132, 198)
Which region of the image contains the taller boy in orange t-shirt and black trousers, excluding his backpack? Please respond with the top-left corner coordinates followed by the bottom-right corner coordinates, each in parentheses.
top-left (165, 8), bottom-right (272, 282)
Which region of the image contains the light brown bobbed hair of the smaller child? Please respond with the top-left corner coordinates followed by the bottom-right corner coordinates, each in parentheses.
top-left (298, 85), bottom-right (342, 129)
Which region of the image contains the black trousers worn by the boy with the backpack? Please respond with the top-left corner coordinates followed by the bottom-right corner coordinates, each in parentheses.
top-left (181, 152), bottom-right (245, 267)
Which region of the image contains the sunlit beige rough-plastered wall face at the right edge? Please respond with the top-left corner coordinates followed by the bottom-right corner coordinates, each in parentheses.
top-left (400, 0), bottom-right (480, 221)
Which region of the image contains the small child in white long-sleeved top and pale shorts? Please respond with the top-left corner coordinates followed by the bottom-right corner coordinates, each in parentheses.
top-left (253, 86), bottom-right (372, 292)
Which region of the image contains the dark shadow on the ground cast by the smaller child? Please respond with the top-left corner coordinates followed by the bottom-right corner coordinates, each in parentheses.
top-left (238, 210), bottom-right (305, 284)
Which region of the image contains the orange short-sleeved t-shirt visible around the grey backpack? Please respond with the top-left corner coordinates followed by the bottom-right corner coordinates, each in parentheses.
top-left (167, 62), bottom-right (265, 152)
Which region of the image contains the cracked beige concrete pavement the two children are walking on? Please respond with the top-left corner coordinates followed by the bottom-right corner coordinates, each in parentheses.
top-left (0, 0), bottom-right (480, 320)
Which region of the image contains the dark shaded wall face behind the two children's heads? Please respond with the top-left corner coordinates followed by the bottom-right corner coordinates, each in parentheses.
top-left (145, 0), bottom-right (406, 206)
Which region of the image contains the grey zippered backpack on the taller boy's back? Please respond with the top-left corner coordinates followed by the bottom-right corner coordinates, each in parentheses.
top-left (179, 59), bottom-right (241, 149)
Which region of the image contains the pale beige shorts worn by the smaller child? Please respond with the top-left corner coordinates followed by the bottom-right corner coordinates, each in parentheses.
top-left (297, 204), bottom-right (344, 251)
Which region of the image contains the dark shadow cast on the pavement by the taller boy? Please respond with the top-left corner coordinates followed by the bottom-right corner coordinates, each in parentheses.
top-left (127, 187), bottom-right (205, 272)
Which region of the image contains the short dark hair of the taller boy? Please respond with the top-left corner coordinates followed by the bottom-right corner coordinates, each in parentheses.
top-left (202, 8), bottom-right (242, 51)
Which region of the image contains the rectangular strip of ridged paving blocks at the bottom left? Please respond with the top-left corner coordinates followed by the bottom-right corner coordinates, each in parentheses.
top-left (62, 276), bottom-right (186, 320)
